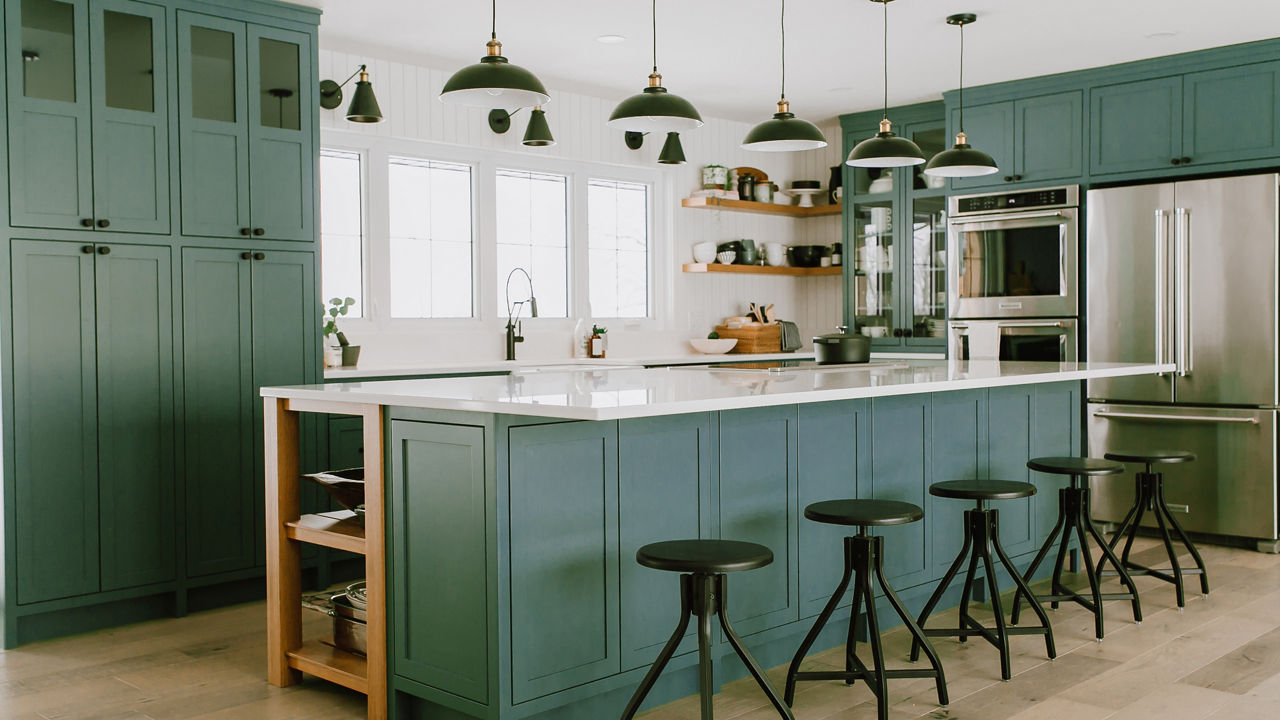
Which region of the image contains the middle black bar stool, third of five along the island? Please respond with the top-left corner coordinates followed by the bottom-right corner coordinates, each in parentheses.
top-left (911, 480), bottom-right (1057, 680)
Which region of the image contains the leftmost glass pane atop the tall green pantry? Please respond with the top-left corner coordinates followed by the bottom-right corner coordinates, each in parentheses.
top-left (22, 0), bottom-right (76, 102)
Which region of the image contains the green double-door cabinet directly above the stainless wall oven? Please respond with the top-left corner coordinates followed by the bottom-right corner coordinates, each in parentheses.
top-left (951, 90), bottom-right (1084, 191)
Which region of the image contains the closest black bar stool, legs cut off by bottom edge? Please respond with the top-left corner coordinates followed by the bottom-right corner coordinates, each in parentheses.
top-left (622, 539), bottom-right (795, 720)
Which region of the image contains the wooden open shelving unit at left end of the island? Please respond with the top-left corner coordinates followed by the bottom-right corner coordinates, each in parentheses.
top-left (262, 397), bottom-right (387, 720)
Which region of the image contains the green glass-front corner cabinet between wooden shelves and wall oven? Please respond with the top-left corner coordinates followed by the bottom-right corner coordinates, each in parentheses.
top-left (845, 106), bottom-right (947, 351)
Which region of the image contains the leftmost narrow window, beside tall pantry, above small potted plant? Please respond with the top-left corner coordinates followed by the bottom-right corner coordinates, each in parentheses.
top-left (320, 149), bottom-right (365, 318)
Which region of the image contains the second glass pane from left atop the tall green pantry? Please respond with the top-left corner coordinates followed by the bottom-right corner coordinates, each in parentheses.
top-left (102, 10), bottom-right (155, 113)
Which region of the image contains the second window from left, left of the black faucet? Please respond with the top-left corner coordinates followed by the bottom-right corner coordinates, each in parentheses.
top-left (388, 156), bottom-right (474, 318)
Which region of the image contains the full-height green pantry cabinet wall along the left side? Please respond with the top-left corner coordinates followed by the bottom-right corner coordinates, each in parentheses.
top-left (0, 0), bottom-right (323, 647)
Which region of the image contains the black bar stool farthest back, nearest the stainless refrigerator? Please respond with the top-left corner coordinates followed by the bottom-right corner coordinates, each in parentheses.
top-left (1098, 450), bottom-right (1208, 604)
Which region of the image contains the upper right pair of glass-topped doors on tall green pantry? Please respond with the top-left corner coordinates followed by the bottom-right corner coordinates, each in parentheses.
top-left (178, 12), bottom-right (316, 242)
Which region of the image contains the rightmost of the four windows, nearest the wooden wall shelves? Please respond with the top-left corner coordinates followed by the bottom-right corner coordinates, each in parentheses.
top-left (586, 179), bottom-right (649, 318)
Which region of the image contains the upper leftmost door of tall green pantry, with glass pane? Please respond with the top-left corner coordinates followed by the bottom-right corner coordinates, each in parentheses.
top-left (5, 0), bottom-right (93, 228)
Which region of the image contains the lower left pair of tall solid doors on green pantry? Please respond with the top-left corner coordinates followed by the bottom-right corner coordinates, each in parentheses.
top-left (10, 240), bottom-right (175, 603)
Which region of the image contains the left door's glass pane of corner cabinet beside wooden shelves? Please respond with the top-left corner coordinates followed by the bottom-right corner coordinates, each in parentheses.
top-left (845, 200), bottom-right (895, 337)
